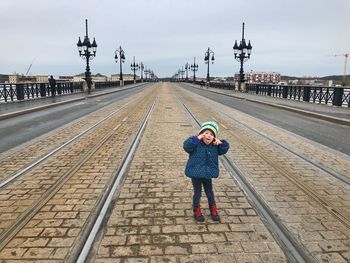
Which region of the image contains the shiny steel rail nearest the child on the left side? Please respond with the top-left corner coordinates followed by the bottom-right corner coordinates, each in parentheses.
top-left (76, 98), bottom-right (157, 263)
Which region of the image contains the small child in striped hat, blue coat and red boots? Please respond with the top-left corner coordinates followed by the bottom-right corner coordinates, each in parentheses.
top-left (183, 121), bottom-right (230, 222)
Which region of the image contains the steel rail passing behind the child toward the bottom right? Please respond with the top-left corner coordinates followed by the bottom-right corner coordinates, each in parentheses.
top-left (180, 95), bottom-right (315, 263)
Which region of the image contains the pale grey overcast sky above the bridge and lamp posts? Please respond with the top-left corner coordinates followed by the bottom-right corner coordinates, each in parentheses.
top-left (0, 0), bottom-right (350, 77)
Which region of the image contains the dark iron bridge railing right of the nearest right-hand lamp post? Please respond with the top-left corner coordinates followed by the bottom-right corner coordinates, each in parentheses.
top-left (246, 83), bottom-right (350, 107)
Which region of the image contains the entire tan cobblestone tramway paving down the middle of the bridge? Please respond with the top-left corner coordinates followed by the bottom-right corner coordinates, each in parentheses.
top-left (0, 84), bottom-right (350, 263)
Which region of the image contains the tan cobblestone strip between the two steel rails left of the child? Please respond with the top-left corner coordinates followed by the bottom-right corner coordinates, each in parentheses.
top-left (0, 86), bottom-right (155, 262)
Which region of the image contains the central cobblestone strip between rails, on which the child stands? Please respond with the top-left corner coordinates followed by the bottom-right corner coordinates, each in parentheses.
top-left (92, 84), bottom-right (286, 262)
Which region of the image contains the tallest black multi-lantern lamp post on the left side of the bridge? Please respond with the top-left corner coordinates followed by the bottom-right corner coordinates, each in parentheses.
top-left (77, 19), bottom-right (97, 94)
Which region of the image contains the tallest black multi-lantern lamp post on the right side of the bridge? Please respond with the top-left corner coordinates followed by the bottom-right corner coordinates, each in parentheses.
top-left (233, 23), bottom-right (252, 91)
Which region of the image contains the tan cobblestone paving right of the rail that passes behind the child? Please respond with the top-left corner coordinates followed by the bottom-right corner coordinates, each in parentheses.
top-left (178, 86), bottom-right (350, 262)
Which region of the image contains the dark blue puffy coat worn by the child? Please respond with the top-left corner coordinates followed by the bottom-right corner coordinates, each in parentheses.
top-left (183, 136), bottom-right (230, 179)
